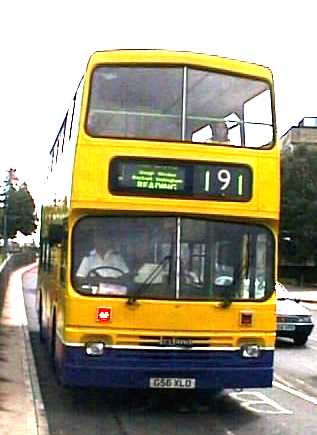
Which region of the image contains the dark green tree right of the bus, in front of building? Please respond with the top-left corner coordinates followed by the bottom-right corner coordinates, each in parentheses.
top-left (280, 146), bottom-right (317, 264)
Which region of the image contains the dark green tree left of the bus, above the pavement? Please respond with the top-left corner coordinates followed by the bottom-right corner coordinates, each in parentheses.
top-left (0, 169), bottom-right (38, 239)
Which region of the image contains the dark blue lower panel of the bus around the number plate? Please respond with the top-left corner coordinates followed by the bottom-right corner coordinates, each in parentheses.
top-left (57, 343), bottom-right (273, 389)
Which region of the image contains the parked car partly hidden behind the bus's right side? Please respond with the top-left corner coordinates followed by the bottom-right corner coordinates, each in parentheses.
top-left (275, 282), bottom-right (314, 345)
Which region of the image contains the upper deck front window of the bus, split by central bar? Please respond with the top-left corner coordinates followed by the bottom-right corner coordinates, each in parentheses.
top-left (86, 66), bottom-right (273, 148)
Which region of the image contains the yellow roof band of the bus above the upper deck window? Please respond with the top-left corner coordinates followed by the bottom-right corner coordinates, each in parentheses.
top-left (88, 49), bottom-right (272, 81)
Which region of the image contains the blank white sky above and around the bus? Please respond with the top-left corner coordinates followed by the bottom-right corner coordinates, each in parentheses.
top-left (0, 0), bottom-right (317, 225)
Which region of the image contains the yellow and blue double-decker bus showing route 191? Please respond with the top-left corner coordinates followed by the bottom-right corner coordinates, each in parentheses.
top-left (37, 50), bottom-right (280, 390)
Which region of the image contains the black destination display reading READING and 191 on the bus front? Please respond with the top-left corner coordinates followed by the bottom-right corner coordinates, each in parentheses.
top-left (109, 158), bottom-right (252, 201)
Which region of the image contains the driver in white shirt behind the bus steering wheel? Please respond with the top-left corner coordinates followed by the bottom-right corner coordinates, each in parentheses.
top-left (76, 233), bottom-right (129, 278)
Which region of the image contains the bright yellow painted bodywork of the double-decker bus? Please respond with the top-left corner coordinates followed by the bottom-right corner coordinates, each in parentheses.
top-left (39, 50), bottom-right (280, 348)
